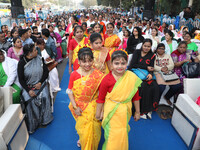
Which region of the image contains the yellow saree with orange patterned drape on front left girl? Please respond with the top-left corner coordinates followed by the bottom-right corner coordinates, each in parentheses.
top-left (69, 70), bottom-right (104, 150)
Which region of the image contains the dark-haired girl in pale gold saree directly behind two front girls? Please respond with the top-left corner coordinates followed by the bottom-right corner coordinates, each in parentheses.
top-left (90, 33), bottom-right (111, 74)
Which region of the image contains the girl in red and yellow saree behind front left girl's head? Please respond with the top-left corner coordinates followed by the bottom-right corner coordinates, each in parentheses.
top-left (69, 26), bottom-right (88, 74)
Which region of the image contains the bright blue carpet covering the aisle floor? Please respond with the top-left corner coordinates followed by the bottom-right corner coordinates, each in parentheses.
top-left (26, 62), bottom-right (187, 150)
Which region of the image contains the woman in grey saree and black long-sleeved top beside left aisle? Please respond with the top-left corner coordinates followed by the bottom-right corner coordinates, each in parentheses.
top-left (17, 44), bottom-right (53, 133)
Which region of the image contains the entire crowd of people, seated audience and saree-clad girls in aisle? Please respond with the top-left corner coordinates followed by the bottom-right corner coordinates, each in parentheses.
top-left (0, 10), bottom-right (200, 150)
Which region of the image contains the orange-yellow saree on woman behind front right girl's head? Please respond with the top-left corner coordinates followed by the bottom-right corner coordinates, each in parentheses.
top-left (104, 34), bottom-right (121, 56)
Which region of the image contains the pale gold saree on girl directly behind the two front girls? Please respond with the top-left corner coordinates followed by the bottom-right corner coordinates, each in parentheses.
top-left (93, 47), bottom-right (109, 75)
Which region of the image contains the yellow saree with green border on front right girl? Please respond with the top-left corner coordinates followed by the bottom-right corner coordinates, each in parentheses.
top-left (102, 71), bottom-right (142, 150)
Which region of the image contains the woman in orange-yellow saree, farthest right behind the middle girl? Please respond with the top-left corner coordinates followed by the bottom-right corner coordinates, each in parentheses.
top-left (104, 23), bottom-right (121, 56)
